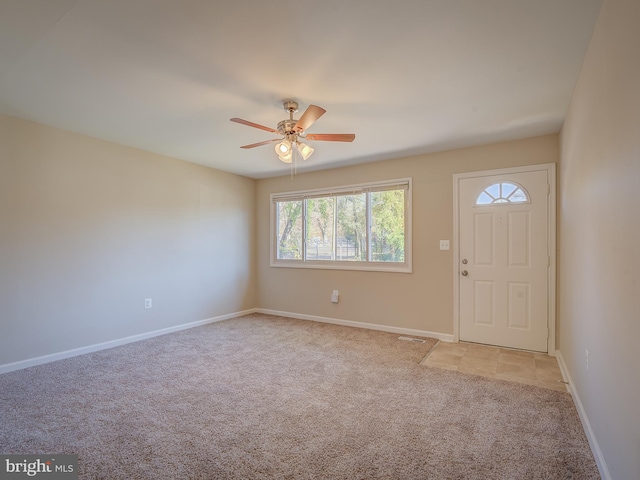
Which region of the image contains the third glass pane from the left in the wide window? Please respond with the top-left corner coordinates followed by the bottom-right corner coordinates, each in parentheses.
top-left (335, 193), bottom-right (367, 261)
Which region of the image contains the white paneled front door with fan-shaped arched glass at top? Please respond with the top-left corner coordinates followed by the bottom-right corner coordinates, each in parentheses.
top-left (457, 169), bottom-right (551, 352)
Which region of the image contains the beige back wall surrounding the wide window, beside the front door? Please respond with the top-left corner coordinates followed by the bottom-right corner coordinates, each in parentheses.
top-left (256, 135), bottom-right (558, 334)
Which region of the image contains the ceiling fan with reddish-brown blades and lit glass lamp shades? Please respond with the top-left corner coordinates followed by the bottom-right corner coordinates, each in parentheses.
top-left (231, 100), bottom-right (356, 163)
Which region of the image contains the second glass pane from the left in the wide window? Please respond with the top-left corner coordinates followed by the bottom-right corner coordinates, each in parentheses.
top-left (306, 197), bottom-right (335, 260)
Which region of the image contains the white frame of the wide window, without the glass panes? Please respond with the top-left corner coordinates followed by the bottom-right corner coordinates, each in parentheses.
top-left (269, 178), bottom-right (413, 273)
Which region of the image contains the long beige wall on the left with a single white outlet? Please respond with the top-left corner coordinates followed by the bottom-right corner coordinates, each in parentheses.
top-left (0, 116), bottom-right (255, 365)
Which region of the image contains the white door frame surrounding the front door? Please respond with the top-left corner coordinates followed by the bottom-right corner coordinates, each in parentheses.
top-left (453, 163), bottom-right (556, 357)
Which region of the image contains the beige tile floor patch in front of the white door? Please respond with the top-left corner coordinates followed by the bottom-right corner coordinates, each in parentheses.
top-left (422, 342), bottom-right (567, 392)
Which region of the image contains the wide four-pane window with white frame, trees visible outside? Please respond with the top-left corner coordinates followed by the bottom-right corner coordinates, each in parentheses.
top-left (271, 179), bottom-right (411, 272)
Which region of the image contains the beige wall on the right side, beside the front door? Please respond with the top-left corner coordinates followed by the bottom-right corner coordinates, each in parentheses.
top-left (558, 0), bottom-right (640, 479)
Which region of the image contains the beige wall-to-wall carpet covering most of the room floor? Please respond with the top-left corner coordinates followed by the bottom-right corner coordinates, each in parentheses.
top-left (0, 315), bottom-right (599, 480)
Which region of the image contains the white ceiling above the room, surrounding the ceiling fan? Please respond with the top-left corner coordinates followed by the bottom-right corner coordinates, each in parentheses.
top-left (0, 0), bottom-right (601, 178)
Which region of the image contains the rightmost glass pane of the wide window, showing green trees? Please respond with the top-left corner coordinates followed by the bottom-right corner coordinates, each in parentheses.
top-left (371, 190), bottom-right (404, 262)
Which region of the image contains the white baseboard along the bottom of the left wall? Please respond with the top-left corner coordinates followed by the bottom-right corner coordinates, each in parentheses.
top-left (0, 308), bottom-right (256, 374)
